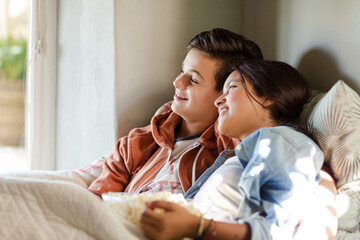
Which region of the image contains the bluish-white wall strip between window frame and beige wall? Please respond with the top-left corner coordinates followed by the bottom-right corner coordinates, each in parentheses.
top-left (56, 0), bottom-right (116, 169)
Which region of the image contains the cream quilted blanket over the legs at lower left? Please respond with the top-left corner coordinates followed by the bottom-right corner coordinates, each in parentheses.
top-left (0, 175), bottom-right (145, 240)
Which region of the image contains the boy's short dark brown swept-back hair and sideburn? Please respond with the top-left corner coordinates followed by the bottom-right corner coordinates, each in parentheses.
top-left (187, 28), bottom-right (263, 91)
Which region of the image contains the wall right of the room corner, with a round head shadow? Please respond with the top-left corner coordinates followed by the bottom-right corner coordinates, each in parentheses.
top-left (243, 0), bottom-right (360, 92)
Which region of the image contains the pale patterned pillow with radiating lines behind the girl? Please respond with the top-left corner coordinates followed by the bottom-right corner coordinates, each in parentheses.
top-left (307, 80), bottom-right (360, 188)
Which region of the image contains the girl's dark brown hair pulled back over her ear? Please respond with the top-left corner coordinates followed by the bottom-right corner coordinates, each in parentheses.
top-left (234, 60), bottom-right (311, 132)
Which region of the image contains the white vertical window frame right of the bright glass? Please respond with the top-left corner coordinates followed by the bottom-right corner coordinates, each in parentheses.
top-left (25, 0), bottom-right (57, 170)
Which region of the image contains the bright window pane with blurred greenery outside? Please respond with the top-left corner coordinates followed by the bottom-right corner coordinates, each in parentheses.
top-left (0, 0), bottom-right (29, 171)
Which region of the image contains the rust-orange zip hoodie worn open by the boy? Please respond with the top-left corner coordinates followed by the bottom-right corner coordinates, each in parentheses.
top-left (89, 110), bottom-right (239, 196)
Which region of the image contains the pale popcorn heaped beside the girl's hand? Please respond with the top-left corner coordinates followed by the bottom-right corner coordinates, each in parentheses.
top-left (101, 192), bottom-right (200, 226)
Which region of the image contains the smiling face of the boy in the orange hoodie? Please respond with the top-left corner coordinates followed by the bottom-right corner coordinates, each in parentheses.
top-left (171, 49), bottom-right (221, 125)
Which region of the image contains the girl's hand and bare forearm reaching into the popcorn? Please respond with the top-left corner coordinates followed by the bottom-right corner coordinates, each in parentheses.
top-left (140, 201), bottom-right (251, 240)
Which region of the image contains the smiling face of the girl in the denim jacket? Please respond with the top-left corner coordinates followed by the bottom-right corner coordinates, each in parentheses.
top-left (215, 71), bottom-right (274, 140)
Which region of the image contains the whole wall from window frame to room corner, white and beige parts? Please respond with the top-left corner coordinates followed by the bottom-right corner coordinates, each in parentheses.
top-left (56, 0), bottom-right (242, 169)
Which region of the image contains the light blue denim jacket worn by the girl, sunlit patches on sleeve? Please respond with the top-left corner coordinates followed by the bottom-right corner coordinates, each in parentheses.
top-left (185, 126), bottom-right (324, 239)
